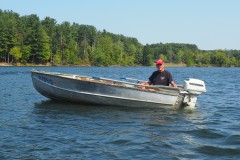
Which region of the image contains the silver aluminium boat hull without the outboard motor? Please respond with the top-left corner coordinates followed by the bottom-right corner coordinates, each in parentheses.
top-left (32, 71), bottom-right (184, 108)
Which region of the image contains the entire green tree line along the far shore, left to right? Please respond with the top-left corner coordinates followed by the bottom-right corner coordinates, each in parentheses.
top-left (0, 9), bottom-right (240, 66)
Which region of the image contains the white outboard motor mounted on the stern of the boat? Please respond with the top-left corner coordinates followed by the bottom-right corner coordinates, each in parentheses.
top-left (183, 78), bottom-right (206, 107)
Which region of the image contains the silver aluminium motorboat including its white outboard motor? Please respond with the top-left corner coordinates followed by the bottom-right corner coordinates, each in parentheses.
top-left (31, 70), bottom-right (206, 108)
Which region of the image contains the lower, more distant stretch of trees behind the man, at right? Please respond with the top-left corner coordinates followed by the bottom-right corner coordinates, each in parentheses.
top-left (143, 43), bottom-right (240, 67)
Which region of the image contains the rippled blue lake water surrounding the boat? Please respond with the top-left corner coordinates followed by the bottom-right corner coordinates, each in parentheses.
top-left (0, 67), bottom-right (240, 159)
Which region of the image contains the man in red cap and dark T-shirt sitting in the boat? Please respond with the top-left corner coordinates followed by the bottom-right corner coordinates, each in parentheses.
top-left (144, 59), bottom-right (177, 87)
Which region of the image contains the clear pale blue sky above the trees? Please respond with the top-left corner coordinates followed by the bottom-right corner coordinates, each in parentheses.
top-left (0, 0), bottom-right (240, 50)
